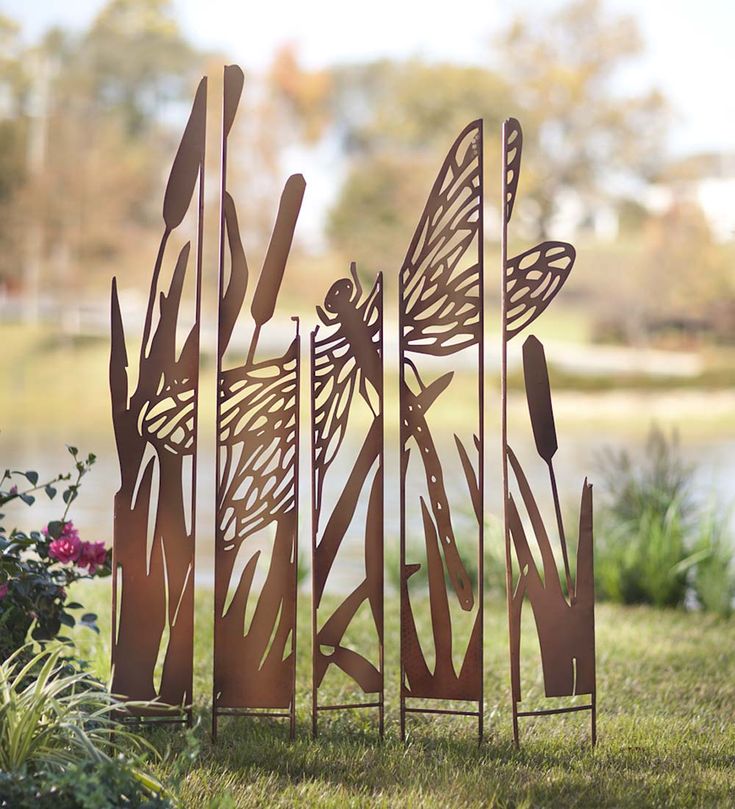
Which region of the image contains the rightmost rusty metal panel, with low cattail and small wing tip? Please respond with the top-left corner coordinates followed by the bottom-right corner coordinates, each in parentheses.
top-left (501, 118), bottom-right (596, 744)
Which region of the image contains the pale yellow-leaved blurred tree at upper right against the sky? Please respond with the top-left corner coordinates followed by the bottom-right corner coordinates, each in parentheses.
top-left (498, 0), bottom-right (667, 238)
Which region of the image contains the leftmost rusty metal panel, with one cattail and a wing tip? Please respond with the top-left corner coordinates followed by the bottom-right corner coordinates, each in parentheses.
top-left (110, 78), bottom-right (207, 717)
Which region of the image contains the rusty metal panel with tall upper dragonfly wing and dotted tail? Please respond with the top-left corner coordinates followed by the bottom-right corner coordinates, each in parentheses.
top-left (399, 121), bottom-right (484, 735)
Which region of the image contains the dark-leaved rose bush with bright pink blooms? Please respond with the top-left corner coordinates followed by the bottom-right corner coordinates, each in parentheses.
top-left (0, 447), bottom-right (111, 661)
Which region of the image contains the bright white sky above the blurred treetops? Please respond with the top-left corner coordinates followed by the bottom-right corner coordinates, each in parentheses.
top-left (5, 0), bottom-right (735, 158)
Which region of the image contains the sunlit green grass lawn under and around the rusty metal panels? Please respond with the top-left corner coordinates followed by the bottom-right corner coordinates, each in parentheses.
top-left (64, 582), bottom-right (735, 809)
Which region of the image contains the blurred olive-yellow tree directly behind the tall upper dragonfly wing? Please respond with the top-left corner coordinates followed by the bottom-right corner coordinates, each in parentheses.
top-left (327, 60), bottom-right (508, 270)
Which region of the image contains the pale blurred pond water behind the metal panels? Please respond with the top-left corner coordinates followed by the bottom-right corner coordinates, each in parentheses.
top-left (0, 392), bottom-right (735, 584)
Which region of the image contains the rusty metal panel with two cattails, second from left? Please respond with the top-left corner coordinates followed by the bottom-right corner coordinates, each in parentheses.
top-left (213, 65), bottom-right (305, 735)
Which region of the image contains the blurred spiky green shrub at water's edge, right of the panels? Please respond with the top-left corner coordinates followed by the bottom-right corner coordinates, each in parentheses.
top-left (595, 429), bottom-right (735, 615)
